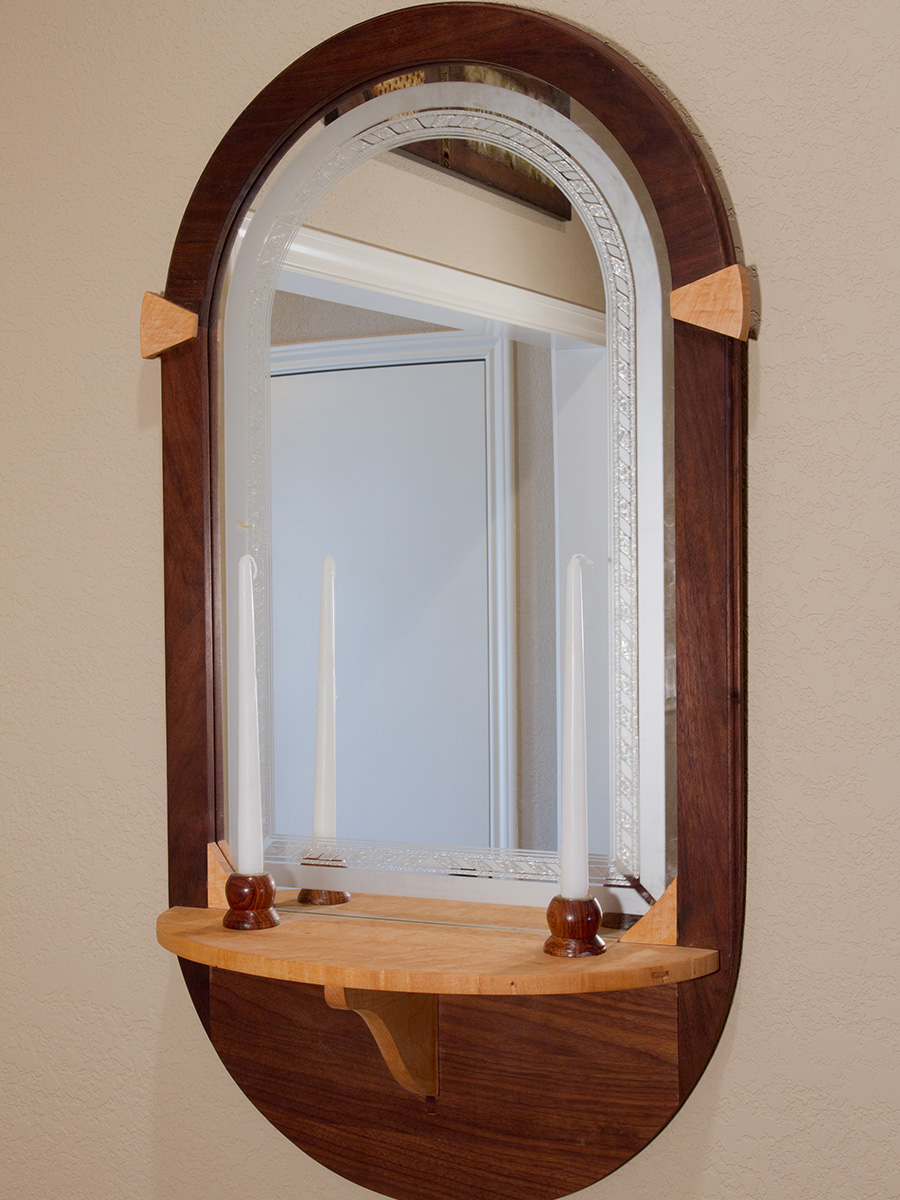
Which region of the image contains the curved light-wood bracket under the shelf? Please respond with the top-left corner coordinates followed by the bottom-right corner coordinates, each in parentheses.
top-left (325, 985), bottom-right (438, 1096)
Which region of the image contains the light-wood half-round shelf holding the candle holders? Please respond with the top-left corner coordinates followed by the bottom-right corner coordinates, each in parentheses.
top-left (157, 908), bottom-right (719, 996)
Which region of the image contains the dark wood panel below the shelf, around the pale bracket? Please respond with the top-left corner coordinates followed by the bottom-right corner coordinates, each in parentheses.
top-left (210, 970), bottom-right (679, 1200)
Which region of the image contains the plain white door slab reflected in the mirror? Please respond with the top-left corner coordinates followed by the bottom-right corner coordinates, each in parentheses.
top-left (270, 362), bottom-right (490, 845)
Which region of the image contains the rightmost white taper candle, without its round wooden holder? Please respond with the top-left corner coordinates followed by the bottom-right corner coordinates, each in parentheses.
top-left (559, 554), bottom-right (588, 900)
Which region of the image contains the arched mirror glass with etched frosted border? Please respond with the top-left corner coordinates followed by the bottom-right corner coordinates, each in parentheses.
top-left (220, 75), bottom-right (676, 911)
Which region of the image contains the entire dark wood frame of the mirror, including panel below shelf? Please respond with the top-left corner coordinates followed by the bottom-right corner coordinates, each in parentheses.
top-left (162, 4), bottom-right (745, 1200)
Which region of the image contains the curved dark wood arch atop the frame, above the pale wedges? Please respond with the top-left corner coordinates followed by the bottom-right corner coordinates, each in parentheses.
top-left (166, 2), bottom-right (734, 322)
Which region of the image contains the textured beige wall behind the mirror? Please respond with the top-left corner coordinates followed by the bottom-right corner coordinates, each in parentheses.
top-left (0, 0), bottom-right (900, 1200)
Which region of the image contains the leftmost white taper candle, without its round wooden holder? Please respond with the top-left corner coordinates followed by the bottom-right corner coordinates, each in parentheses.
top-left (235, 554), bottom-right (265, 875)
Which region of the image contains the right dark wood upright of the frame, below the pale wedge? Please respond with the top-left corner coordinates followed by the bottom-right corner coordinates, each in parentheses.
top-left (674, 323), bottom-right (746, 1096)
